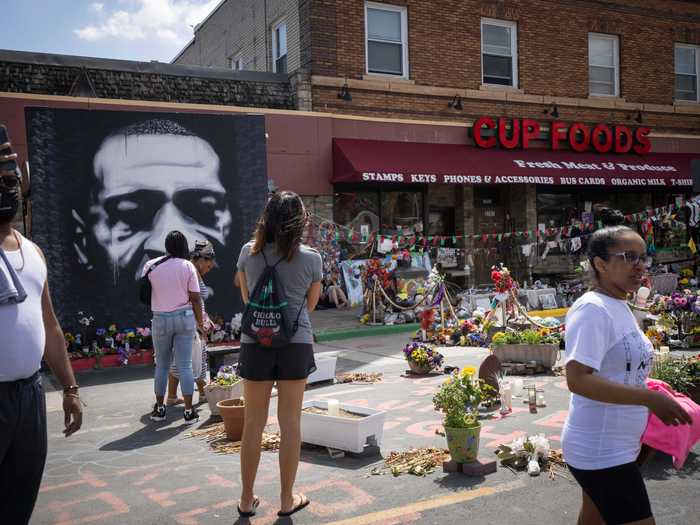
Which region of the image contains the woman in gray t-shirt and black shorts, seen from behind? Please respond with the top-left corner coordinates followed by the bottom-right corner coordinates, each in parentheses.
top-left (238, 191), bottom-right (322, 517)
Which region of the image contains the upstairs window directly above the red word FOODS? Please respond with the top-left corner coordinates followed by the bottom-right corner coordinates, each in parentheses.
top-left (588, 33), bottom-right (620, 97)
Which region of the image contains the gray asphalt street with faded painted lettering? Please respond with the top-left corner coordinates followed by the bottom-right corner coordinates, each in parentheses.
top-left (31, 334), bottom-right (700, 525)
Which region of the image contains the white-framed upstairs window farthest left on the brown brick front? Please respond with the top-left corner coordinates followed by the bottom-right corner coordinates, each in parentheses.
top-left (365, 2), bottom-right (408, 78)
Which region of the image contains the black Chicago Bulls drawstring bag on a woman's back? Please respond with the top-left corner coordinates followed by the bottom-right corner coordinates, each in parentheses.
top-left (241, 251), bottom-right (304, 348)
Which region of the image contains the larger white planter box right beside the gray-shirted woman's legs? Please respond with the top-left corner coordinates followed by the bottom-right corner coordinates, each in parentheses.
top-left (301, 401), bottom-right (386, 454)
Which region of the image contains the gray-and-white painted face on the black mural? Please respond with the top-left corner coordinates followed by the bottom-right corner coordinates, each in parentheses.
top-left (74, 125), bottom-right (232, 281)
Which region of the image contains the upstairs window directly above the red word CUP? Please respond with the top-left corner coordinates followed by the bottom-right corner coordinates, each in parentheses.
top-left (481, 18), bottom-right (518, 88)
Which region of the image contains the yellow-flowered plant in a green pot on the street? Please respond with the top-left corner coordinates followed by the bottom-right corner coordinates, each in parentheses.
top-left (433, 367), bottom-right (491, 463)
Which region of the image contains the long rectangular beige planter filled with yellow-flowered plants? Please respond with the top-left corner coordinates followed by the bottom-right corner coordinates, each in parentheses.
top-left (491, 328), bottom-right (561, 368)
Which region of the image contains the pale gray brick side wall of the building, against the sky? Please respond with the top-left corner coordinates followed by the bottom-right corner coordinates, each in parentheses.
top-left (173, 0), bottom-right (301, 73)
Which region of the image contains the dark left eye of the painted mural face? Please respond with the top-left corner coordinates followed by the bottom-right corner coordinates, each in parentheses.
top-left (104, 190), bottom-right (167, 234)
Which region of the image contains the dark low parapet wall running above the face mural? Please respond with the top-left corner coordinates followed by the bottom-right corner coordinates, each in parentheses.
top-left (0, 51), bottom-right (295, 109)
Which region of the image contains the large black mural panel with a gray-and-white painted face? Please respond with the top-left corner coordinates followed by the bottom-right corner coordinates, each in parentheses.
top-left (27, 109), bottom-right (267, 326)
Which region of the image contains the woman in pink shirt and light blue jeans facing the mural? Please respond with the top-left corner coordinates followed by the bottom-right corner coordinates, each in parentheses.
top-left (143, 231), bottom-right (204, 425)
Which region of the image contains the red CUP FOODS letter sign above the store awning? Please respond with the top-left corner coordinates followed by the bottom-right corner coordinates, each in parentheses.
top-left (472, 117), bottom-right (651, 155)
